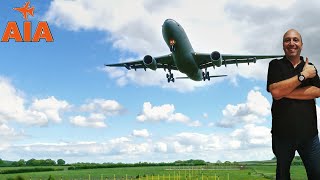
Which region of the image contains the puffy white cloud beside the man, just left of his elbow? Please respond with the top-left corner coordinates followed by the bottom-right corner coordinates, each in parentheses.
top-left (217, 90), bottom-right (271, 127)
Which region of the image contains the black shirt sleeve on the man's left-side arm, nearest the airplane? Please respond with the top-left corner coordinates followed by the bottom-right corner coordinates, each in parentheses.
top-left (267, 59), bottom-right (281, 92)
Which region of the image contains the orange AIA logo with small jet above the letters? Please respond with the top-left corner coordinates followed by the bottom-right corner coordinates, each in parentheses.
top-left (1, 1), bottom-right (53, 42)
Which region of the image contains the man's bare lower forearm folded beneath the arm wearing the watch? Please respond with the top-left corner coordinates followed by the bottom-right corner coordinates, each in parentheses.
top-left (285, 86), bottom-right (320, 100)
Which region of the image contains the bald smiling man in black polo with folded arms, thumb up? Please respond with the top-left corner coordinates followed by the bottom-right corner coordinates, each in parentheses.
top-left (267, 29), bottom-right (320, 180)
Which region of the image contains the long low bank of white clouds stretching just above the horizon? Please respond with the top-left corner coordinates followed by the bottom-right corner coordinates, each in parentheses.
top-left (0, 124), bottom-right (273, 163)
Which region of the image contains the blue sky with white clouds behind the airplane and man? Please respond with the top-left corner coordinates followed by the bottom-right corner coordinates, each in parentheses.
top-left (0, 0), bottom-right (320, 163)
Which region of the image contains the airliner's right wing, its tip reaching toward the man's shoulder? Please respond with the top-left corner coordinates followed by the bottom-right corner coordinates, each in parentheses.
top-left (192, 53), bottom-right (284, 69)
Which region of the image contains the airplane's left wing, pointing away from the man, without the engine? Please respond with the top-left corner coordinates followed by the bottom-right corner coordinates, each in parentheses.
top-left (105, 54), bottom-right (178, 70)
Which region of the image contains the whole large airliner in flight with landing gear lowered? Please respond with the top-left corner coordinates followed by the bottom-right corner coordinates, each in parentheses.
top-left (105, 19), bottom-right (283, 83)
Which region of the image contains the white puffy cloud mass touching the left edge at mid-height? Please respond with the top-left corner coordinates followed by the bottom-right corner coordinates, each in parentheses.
top-left (0, 77), bottom-right (69, 126)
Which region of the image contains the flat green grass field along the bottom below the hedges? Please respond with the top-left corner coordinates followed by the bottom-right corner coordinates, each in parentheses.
top-left (0, 164), bottom-right (307, 180)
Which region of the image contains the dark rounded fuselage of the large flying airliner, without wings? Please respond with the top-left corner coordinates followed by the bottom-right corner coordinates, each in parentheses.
top-left (162, 19), bottom-right (202, 81)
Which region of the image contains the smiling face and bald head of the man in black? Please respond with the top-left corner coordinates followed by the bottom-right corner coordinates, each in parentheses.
top-left (283, 30), bottom-right (303, 58)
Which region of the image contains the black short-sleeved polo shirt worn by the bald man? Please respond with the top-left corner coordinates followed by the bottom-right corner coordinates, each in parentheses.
top-left (267, 57), bottom-right (320, 139)
